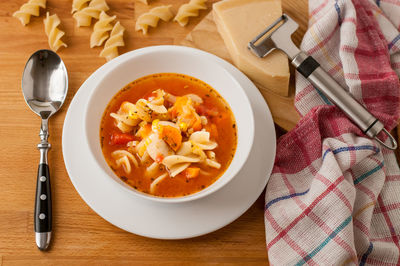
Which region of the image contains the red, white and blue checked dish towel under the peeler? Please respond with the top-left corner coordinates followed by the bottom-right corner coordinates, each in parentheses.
top-left (265, 0), bottom-right (400, 265)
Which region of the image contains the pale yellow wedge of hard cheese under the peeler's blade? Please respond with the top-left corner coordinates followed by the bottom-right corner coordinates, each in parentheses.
top-left (213, 0), bottom-right (290, 96)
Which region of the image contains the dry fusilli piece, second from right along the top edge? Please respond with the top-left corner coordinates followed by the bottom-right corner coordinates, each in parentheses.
top-left (135, 5), bottom-right (174, 34)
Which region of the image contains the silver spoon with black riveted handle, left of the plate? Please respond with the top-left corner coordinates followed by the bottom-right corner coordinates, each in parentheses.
top-left (22, 50), bottom-right (68, 250)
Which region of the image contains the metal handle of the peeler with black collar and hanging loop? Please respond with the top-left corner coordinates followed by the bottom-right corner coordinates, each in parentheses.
top-left (292, 52), bottom-right (397, 150)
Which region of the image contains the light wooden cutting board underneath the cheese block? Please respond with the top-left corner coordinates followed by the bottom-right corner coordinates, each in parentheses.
top-left (181, 0), bottom-right (308, 130)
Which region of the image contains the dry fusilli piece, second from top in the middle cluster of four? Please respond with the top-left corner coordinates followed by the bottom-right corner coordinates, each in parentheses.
top-left (72, 0), bottom-right (110, 27)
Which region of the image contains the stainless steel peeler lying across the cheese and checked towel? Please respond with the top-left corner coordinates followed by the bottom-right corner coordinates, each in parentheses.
top-left (248, 14), bottom-right (397, 150)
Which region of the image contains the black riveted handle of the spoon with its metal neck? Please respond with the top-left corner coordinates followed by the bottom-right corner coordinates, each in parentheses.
top-left (34, 119), bottom-right (52, 250)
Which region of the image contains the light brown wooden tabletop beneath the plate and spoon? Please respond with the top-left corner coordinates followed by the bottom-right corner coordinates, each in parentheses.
top-left (0, 0), bottom-right (307, 265)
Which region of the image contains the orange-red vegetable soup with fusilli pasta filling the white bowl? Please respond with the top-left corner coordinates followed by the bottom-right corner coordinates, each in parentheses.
top-left (100, 73), bottom-right (237, 197)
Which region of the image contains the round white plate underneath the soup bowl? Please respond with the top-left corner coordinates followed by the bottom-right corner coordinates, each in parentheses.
top-left (62, 46), bottom-right (276, 239)
